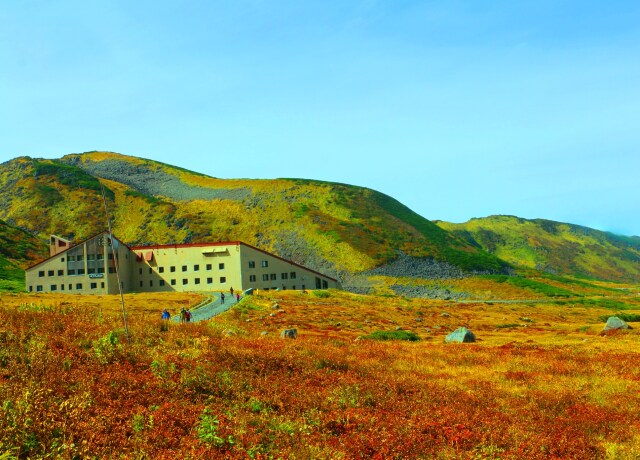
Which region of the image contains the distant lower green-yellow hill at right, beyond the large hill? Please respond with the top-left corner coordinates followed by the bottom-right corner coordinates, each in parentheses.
top-left (438, 216), bottom-right (640, 282)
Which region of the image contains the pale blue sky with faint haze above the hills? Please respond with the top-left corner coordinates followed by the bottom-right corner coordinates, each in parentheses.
top-left (0, 0), bottom-right (640, 235)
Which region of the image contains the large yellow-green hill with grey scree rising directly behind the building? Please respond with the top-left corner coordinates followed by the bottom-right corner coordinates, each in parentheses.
top-left (0, 152), bottom-right (507, 275)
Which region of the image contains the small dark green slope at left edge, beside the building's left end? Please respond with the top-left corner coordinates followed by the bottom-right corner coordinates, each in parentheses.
top-left (0, 221), bottom-right (48, 292)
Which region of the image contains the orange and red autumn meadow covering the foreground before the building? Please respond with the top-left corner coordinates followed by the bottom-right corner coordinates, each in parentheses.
top-left (0, 281), bottom-right (640, 459)
